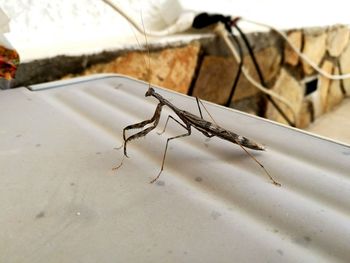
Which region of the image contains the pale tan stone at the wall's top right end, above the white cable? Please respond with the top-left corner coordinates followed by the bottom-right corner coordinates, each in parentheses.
top-left (327, 26), bottom-right (350, 57)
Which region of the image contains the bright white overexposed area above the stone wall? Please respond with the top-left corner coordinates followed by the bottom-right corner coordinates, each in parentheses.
top-left (0, 0), bottom-right (350, 61)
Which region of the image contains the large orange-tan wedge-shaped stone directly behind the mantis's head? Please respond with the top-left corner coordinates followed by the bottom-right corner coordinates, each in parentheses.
top-left (84, 42), bottom-right (200, 94)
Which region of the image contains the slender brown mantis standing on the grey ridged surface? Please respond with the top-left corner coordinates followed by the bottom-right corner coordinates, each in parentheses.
top-left (114, 87), bottom-right (281, 186)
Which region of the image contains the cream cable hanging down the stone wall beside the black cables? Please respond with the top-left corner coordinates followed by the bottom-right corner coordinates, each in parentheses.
top-left (214, 23), bottom-right (297, 122)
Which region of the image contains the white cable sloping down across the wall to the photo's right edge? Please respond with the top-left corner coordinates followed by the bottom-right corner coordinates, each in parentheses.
top-left (239, 18), bottom-right (350, 80)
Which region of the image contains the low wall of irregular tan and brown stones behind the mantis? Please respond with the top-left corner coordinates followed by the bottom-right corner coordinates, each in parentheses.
top-left (11, 25), bottom-right (350, 128)
